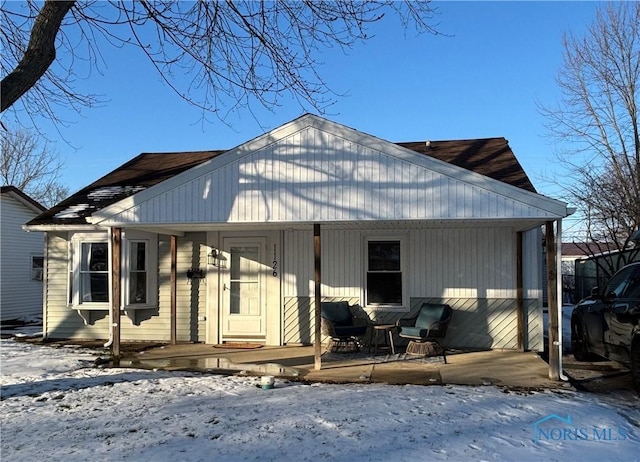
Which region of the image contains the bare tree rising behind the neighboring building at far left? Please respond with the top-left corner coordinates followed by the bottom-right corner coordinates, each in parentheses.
top-left (0, 124), bottom-right (69, 207)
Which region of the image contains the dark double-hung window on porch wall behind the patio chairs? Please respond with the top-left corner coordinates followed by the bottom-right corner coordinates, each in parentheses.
top-left (366, 240), bottom-right (402, 306)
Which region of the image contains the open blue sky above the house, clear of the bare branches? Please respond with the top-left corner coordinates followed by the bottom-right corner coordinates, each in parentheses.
top-left (11, 2), bottom-right (598, 235)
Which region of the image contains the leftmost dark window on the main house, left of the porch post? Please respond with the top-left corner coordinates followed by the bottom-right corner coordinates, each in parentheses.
top-left (79, 242), bottom-right (109, 303)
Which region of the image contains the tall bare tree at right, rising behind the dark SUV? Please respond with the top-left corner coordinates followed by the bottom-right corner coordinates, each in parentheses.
top-left (542, 2), bottom-right (640, 275)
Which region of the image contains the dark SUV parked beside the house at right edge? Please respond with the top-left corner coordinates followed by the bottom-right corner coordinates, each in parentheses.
top-left (571, 262), bottom-right (640, 393)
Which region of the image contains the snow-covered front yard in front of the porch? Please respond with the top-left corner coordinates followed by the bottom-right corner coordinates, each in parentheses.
top-left (0, 324), bottom-right (640, 462)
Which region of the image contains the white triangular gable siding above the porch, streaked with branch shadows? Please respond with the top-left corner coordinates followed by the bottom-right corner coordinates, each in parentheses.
top-left (102, 128), bottom-right (549, 223)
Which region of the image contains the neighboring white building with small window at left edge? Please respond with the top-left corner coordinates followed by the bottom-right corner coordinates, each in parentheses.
top-left (0, 186), bottom-right (46, 321)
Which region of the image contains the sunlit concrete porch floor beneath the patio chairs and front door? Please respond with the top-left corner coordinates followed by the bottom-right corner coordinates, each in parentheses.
top-left (120, 344), bottom-right (570, 390)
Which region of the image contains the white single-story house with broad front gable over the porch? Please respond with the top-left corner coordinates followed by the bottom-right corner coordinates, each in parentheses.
top-left (28, 114), bottom-right (568, 350)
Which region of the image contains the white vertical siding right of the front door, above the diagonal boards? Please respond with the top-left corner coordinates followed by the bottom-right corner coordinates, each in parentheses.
top-left (284, 227), bottom-right (524, 298)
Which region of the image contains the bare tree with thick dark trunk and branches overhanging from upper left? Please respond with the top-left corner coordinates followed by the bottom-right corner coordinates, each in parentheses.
top-left (0, 0), bottom-right (436, 125)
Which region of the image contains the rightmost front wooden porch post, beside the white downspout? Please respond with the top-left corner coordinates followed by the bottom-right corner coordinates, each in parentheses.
top-left (545, 221), bottom-right (562, 380)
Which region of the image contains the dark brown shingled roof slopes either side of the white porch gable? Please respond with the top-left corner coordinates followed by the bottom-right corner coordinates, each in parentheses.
top-left (27, 138), bottom-right (536, 225)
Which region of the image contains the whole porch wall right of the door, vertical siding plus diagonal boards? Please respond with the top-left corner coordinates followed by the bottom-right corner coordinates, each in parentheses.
top-left (283, 228), bottom-right (543, 350)
